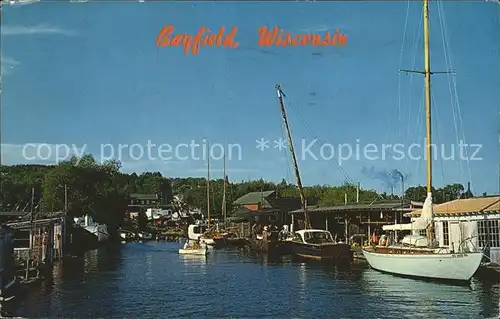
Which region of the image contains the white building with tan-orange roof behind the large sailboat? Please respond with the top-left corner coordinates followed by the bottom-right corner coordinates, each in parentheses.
top-left (411, 196), bottom-right (500, 265)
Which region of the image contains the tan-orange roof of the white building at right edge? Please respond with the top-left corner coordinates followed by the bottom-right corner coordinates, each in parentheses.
top-left (412, 196), bottom-right (500, 215)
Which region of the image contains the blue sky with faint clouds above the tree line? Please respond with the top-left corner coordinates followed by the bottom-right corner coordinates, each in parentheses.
top-left (1, 1), bottom-right (500, 193)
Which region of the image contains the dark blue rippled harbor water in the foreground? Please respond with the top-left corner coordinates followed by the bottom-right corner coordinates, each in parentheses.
top-left (4, 242), bottom-right (500, 318)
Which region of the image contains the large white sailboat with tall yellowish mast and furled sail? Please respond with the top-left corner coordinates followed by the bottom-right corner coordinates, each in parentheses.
top-left (362, 0), bottom-right (483, 281)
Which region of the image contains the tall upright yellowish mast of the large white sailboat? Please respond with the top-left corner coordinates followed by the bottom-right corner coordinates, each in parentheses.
top-left (424, 0), bottom-right (434, 240)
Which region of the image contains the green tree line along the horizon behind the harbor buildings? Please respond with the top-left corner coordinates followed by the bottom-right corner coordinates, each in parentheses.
top-left (0, 155), bottom-right (473, 227)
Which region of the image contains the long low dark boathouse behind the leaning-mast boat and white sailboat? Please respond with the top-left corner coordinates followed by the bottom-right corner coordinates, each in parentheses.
top-left (289, 201), bottom-right (422, 244)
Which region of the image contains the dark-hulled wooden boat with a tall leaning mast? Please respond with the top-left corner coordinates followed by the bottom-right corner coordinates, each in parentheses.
top-left (276, 85), bottom-right (352, 261)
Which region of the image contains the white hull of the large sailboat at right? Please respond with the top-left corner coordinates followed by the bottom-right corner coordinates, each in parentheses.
top-left (362, 249), bottom-right (483, 281)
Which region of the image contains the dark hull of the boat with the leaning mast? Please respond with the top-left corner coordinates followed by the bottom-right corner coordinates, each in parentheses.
top-left (291, 241), bottom-right (352, 261)
